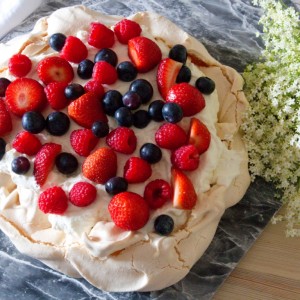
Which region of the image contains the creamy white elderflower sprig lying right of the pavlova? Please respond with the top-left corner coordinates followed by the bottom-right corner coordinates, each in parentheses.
top-left (242, 0), bottom-right (300, 236)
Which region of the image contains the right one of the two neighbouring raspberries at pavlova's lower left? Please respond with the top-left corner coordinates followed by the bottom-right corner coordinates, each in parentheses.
top-left (69, 181), bottom-right (97, 207)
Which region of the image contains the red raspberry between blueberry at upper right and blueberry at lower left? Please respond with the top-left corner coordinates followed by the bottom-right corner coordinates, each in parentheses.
top-left (123, 157), bottom-right (152, 183)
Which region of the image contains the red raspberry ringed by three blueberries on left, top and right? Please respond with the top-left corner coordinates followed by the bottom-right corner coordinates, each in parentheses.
top-left (93, 61), bottom-right (118, 84)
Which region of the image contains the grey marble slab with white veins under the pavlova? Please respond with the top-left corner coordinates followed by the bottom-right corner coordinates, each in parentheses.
top-left (0, 0), bottom-right (290, 300)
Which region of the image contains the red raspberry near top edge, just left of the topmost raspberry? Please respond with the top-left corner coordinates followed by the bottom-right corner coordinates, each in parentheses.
top-left (88, 22), bottom-right (115, 49)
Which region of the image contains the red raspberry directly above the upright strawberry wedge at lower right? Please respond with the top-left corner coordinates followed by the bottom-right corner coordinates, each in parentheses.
top-left (171, 145), bottom-right (200, 171)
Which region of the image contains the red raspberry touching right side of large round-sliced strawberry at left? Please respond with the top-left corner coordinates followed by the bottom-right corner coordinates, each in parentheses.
top-left (45, 82), bottom-right (70, 110)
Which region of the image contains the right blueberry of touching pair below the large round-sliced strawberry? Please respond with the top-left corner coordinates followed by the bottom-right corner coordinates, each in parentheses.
top-left (46, 111), bottom-right (70, 136)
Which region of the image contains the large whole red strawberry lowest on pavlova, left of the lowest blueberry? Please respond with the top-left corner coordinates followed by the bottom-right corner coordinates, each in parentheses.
top-left (108, 192), bottom-right (150, 230)
